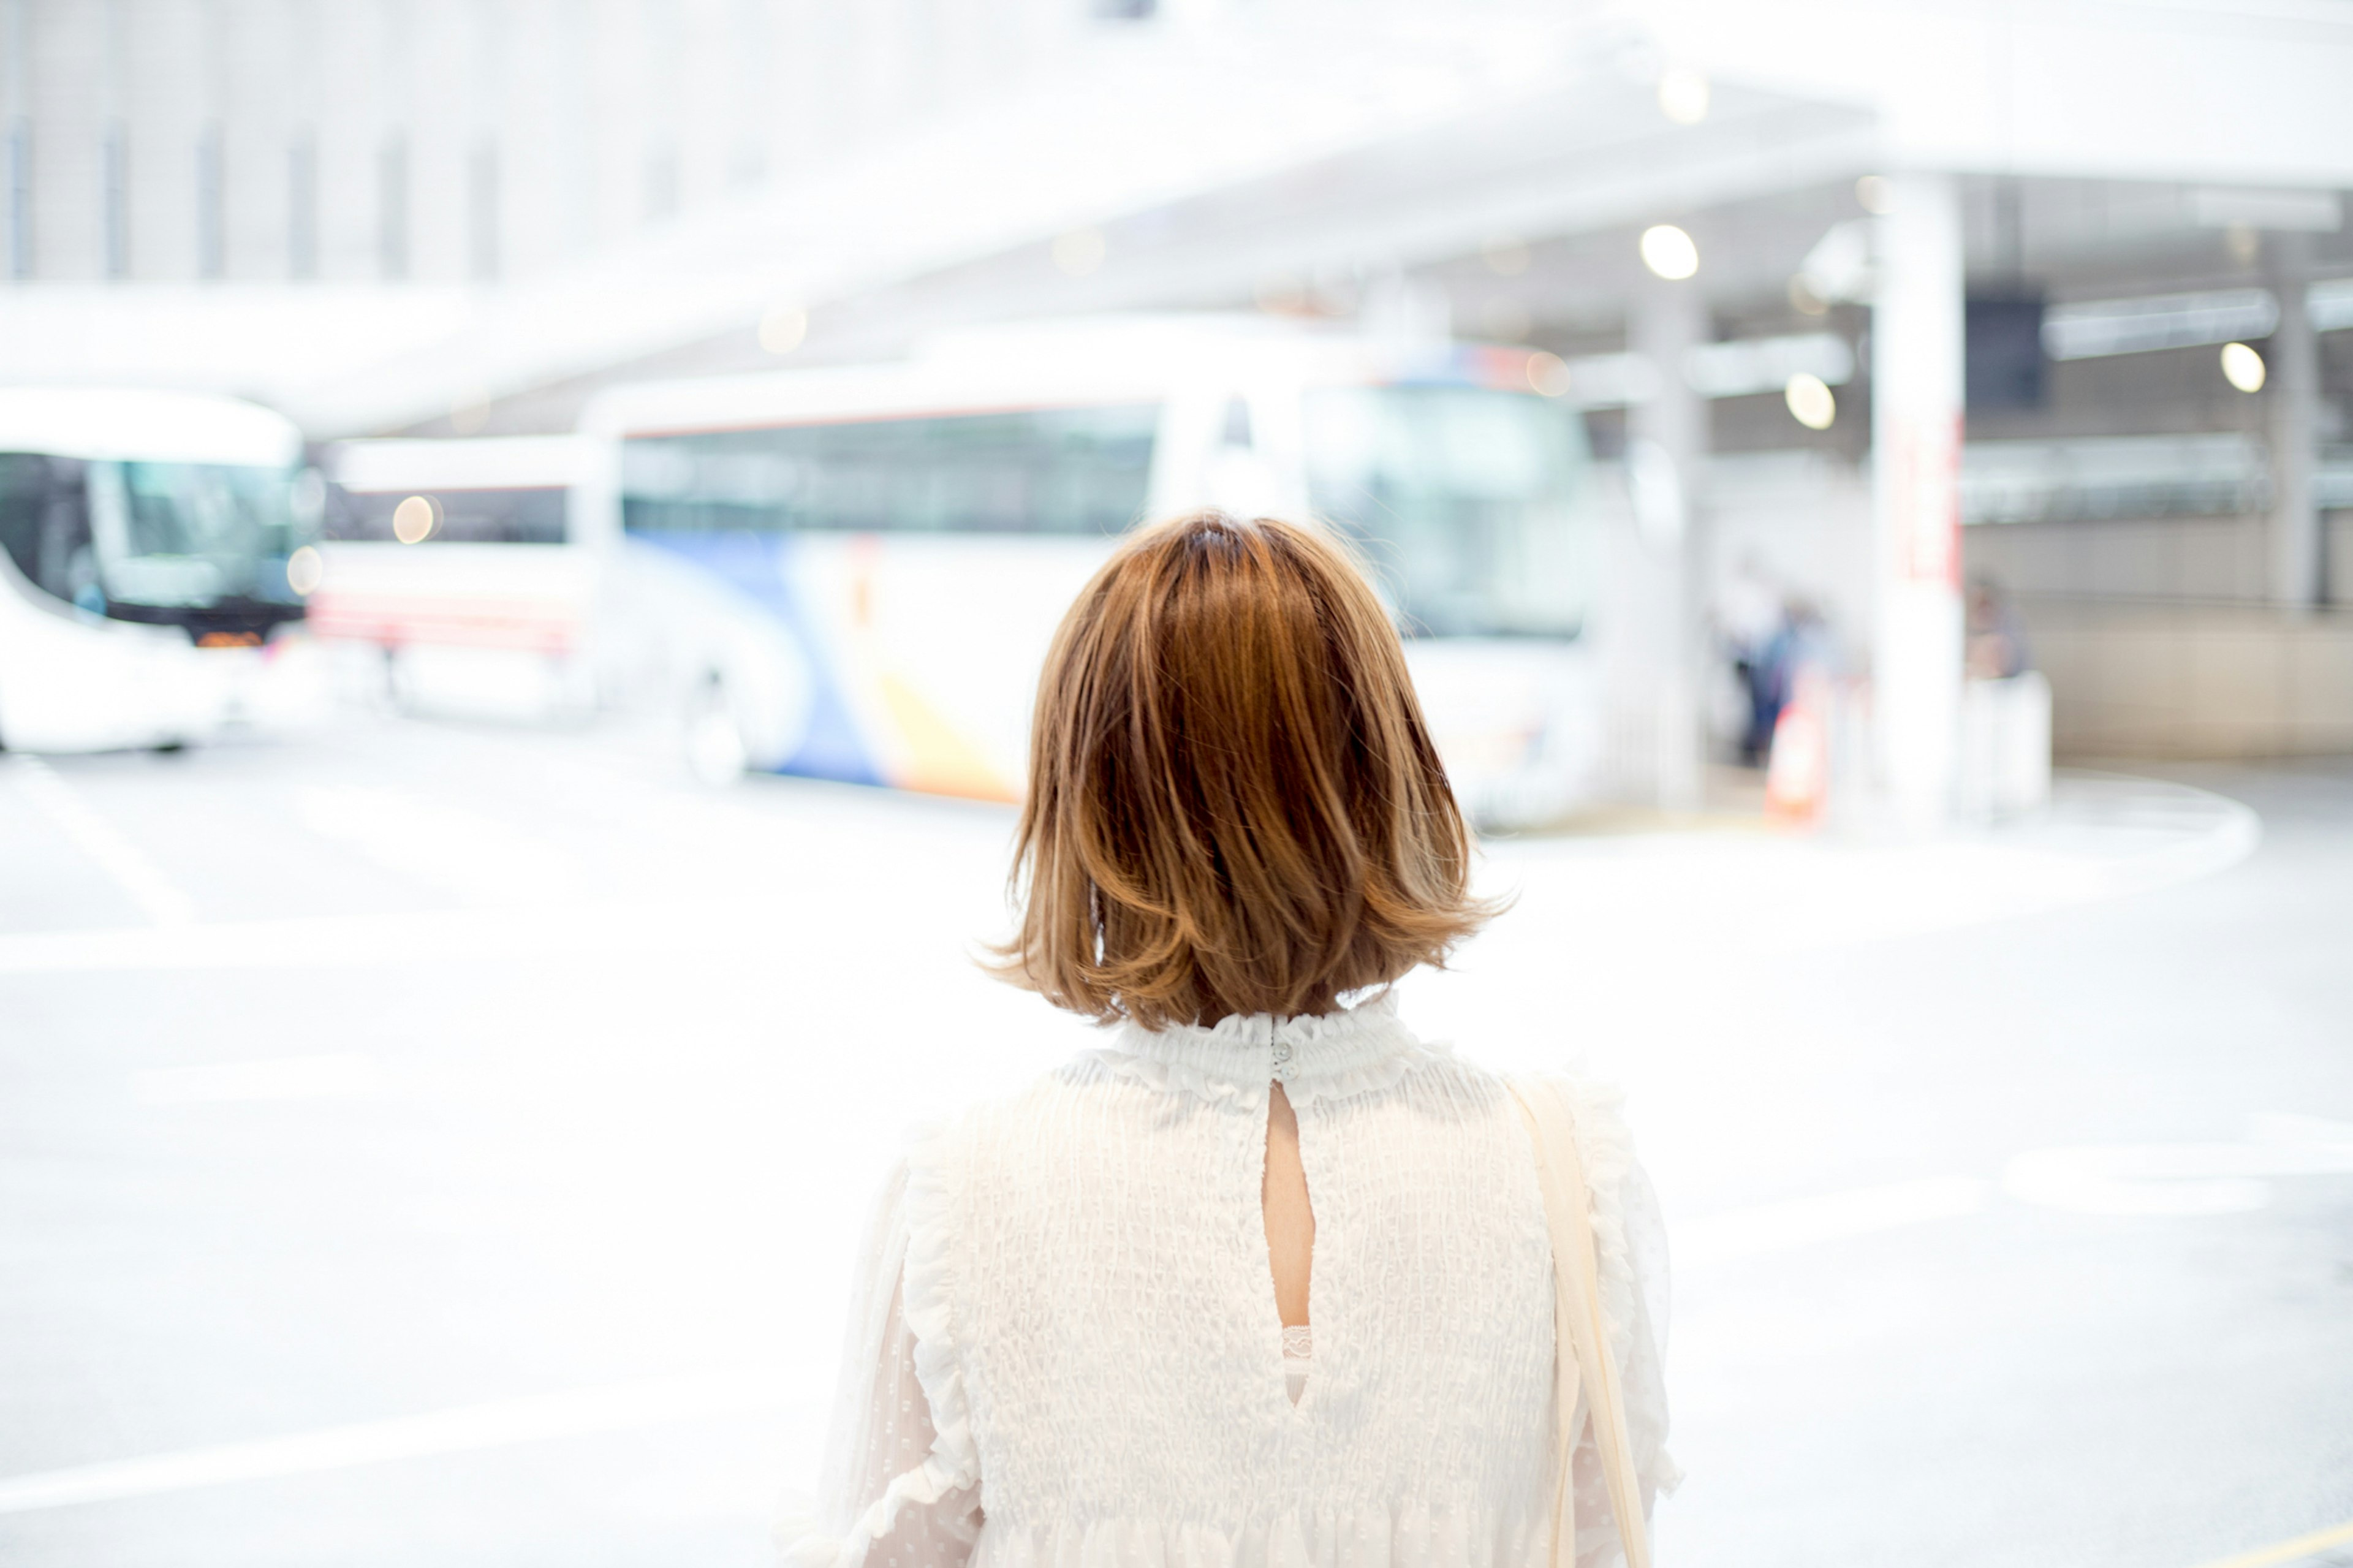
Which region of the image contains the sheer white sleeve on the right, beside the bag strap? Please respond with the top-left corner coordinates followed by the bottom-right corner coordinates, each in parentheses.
top-left (1569, 1088), bottom-right (1683, 1568)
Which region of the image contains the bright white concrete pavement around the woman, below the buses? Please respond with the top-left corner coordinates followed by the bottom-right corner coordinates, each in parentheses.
top-left (0, 721), bottom-right (2353, 1568)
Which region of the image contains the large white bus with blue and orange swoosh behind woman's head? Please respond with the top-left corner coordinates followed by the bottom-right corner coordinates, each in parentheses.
top-left (577, 320), bottom-right (1600, 824)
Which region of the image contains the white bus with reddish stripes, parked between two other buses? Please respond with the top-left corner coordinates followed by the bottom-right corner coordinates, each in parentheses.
top-left (311, 436), bottom-right (597, 718)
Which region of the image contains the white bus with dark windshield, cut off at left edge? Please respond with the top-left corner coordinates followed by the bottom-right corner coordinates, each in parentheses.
top-left (0, 386), bottom-right (325, 751)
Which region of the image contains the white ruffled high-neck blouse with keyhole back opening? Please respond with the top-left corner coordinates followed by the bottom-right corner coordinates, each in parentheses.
top-left (779, 998), bottom-right (1675, 1568)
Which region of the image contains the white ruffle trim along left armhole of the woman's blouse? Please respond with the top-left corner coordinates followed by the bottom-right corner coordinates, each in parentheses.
top-left (776, 1127), bottom-right (981, 1568)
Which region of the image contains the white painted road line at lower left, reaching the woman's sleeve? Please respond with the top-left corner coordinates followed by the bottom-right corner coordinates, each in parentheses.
top-left (0, 1370), bottom-right (784, 1514)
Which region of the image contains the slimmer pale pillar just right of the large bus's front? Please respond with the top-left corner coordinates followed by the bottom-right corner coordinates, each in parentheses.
top-left (1626, 278), bottom-right (1708, 812)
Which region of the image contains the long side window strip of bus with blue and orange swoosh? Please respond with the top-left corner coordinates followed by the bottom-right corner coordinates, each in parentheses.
top-left (621, 405), bottom-right (1160, 534)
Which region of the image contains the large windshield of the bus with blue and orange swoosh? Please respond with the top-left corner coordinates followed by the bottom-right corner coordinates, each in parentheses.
top-left (1303, 386), bottom-right (1591, 635)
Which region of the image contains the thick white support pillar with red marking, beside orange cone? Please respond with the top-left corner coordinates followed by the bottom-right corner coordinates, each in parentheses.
top-left (1871, 174), bottom-right (1963, 829)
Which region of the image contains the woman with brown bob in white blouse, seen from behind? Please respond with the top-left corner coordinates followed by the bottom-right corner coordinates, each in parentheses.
top-left (784, 513), bottom-right (1673, 1568)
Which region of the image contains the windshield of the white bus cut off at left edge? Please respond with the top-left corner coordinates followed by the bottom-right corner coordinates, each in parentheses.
top-left (89, 461), bottom-right (320, 610)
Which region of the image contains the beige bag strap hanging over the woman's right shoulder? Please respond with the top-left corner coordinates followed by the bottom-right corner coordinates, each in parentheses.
top-left (1506, 1076), bottom-right (1650, 1568)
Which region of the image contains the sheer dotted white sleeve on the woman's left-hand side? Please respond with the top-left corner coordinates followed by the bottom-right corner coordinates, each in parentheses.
top-left (776, 1163), bottom-right (981, 1568)
